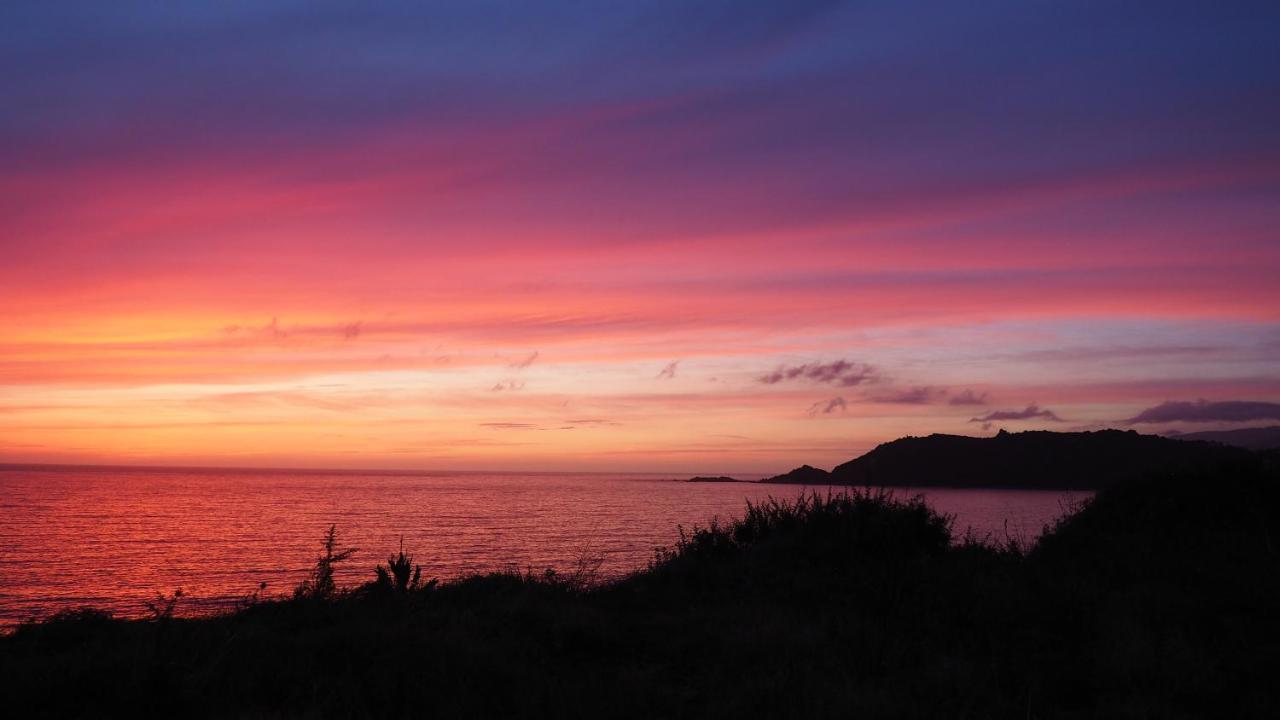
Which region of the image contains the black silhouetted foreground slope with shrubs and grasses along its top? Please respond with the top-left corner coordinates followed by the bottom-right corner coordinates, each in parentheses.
top-left (0, 448), bottom-right (1280, 719)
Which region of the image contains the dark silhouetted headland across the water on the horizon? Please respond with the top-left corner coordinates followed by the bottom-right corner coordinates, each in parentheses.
top-left (768, 430), bottom-right (1248, 489)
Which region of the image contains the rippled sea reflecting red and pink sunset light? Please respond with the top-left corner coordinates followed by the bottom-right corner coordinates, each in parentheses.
top-left (0, 469), bottom-right (1084, 626)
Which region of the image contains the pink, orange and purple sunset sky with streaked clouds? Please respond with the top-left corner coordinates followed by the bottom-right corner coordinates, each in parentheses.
top-left (0, 0), bottom-right (1280, 473)
